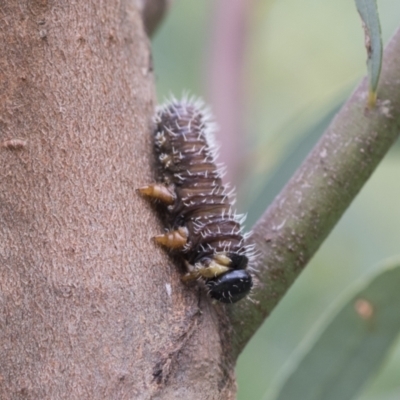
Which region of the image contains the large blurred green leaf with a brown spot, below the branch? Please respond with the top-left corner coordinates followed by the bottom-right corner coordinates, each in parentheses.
top-left (267, 260), bottom-right (400, 400)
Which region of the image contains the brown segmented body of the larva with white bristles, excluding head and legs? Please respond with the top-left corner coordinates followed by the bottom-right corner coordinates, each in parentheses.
top-left (155, 102), bottom-right (246, 263)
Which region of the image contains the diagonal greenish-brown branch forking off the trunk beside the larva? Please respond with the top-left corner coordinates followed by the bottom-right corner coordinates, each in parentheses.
top-left (230, 30), bottom-right (400, 357)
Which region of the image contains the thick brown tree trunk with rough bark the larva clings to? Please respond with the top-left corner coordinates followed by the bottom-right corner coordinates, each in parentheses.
top-left (0, 0), bottom-right (235, 399)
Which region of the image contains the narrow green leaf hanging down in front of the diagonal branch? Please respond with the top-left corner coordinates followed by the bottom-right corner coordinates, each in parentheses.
top-left (356, 0), bottom-right (383, 107)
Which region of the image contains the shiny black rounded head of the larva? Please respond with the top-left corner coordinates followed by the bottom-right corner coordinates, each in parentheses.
top-left (206, 269), bottom-right (253, 303)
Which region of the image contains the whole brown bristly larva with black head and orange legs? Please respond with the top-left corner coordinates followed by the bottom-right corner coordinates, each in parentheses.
top-left (140, 100), bottom-right (252, 303)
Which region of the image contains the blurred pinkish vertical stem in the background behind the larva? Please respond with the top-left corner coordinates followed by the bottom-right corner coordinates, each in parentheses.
top-left (209, 0), bottom-right (251, 183)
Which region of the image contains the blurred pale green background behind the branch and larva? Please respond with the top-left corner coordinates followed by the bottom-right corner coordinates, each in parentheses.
top-left (153, 0), bottom-right (400, 400)
